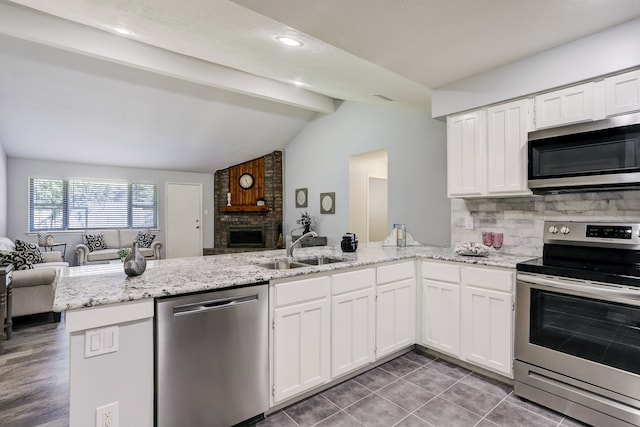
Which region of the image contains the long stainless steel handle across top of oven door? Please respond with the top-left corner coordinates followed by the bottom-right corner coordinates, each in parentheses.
top-left (517, 273), bottom-right (640, 305)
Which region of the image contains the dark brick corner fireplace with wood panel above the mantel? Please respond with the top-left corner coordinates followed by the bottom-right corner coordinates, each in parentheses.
top-left (212, 151), bottom-right (283, 255)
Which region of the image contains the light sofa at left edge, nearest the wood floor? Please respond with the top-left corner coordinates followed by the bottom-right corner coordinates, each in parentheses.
top-left (0, 237), bottom-right (69, 321)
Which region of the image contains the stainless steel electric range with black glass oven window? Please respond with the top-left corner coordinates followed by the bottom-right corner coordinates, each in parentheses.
top-left (514, 222), bottom-right (640, 426)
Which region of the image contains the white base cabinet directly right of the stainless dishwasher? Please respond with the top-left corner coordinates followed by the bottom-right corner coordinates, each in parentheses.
top-left (270, 276), bottom-right (331, 404)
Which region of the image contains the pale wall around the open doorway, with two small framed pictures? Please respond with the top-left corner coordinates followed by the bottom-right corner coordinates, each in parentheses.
top-left (284, 102), bottom-right (451, 245)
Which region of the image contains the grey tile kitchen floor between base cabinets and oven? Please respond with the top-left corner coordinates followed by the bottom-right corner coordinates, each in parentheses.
top-left (257, 351), bottom-right (585, 427)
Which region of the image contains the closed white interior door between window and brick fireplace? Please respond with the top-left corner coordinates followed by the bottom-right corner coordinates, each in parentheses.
top-left (166, 183), bottom-right (202, 258)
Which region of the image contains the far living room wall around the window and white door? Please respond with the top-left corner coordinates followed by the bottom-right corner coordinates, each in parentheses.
top-left (6, 158), bottom-right (214, 265)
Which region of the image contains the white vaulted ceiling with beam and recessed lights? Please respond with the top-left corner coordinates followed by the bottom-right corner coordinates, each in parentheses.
top-left (0, 0), bottom-right (640, 172)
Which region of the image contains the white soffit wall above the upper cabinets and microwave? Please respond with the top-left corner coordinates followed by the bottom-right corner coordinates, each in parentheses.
top-left (431, 18), bottom-right (640, 117)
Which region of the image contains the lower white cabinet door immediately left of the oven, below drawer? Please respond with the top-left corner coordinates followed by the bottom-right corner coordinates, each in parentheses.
top-left (462, 285), bottom-right (513, 378)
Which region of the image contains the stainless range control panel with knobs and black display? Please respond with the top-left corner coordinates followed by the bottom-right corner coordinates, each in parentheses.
top-left (543, 221), bottom-right (640, 249)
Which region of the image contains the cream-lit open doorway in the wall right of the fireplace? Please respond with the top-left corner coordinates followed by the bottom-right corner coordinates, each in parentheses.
top-left (349, 150), bottom-right (388, 243)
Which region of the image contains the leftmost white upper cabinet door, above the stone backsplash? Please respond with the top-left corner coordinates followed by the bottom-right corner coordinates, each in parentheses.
top-left (447, 110), bottom-right (487, 197)
